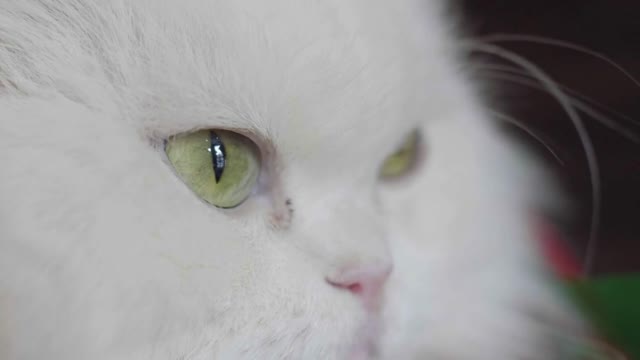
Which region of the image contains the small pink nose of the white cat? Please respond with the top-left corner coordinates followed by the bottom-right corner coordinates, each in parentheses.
top-left (327, 263), bottom-right (393, 306)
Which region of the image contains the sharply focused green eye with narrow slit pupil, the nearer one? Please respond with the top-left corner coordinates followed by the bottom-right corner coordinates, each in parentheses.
top-left (165, 130), bottom-right (260, 208)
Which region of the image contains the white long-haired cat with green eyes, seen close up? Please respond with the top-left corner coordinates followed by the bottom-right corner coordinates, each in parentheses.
top-left (0, 0), bottom-right (584, 360)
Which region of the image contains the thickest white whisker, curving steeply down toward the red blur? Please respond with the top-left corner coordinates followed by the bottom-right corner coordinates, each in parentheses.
top-left (462, 40), bottom-right (601, 276)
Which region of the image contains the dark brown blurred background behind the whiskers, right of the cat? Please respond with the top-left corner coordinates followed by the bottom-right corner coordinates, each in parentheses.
top-left (461, 0), bottom-right (640, 273)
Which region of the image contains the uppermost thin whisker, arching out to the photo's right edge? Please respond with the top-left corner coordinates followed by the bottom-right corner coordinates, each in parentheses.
top-left (477, 34), bottom-right (640, 87)
